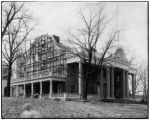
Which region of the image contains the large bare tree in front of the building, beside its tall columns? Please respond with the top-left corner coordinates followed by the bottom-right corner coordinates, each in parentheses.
top-left (69, 5), bottom-right (117, 100)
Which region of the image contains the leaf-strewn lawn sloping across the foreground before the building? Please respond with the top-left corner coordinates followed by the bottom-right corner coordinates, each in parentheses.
top-left (1, 98), bottom-right (148, 118)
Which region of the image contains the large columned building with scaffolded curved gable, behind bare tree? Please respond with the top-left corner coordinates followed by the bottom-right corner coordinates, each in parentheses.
top-left (11, 35), bottom-right (136, 99)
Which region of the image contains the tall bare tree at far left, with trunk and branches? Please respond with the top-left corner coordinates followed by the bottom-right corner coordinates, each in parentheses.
top-left (2, 2), bottom-right (34, 97)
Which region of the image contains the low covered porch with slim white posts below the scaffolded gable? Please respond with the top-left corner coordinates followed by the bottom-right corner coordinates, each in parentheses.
top-left (11, 78), bottom-right (66, 99)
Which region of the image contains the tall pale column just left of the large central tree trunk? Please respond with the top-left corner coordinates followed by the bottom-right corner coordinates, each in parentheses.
top-left (78, 62), bottom-right (83, 99)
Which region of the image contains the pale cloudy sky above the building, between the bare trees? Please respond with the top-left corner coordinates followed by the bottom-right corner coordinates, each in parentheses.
top-left (25, 2), bottom-right (148, 63)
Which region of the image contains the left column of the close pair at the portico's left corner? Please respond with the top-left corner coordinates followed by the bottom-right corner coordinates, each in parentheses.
top-left (106, 66), bottom-right (110, 99)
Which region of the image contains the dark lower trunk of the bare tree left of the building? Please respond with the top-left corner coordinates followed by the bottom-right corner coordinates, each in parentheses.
top-left (6, 64), bottom-right (12, 97)
